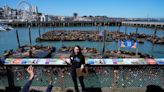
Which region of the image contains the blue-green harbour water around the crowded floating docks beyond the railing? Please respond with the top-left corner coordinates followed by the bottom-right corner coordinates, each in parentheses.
top-left (0, 26), bottom-right (164, 58)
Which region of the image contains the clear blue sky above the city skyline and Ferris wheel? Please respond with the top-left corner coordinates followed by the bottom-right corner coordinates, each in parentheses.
top-left (0, 0), bottom-right (164, 18)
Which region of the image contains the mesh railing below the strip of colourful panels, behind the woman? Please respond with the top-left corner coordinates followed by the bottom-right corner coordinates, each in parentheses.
top-left (0, 65), bottom-right (164, 88)
